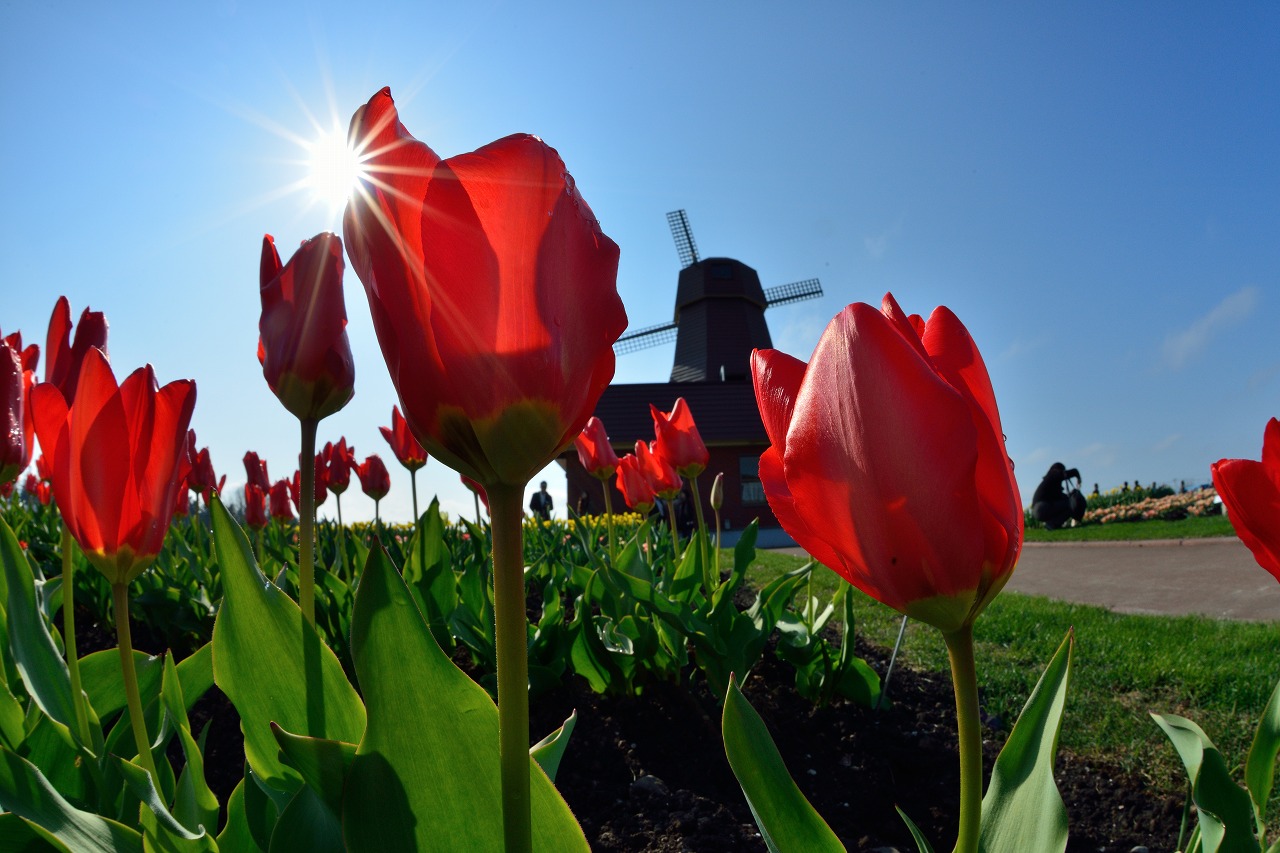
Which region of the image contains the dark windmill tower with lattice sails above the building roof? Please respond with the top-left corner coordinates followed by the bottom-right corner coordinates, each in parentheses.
top-left (613, 210), bottom-right (822, 382)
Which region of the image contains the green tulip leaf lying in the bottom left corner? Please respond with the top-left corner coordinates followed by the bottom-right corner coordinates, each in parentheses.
top-left (0, 749), bottom-right (142, 853)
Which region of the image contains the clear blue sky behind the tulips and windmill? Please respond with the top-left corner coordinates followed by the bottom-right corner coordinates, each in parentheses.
top-left (0, 0), bottom-right (1280, 520)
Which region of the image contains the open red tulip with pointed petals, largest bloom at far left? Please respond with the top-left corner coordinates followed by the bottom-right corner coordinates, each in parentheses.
top-left (32, 350), bottom-right (196, 584)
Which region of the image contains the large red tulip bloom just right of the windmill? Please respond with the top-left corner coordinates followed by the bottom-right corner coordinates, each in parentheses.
top-left (751, 296), bottom-right (1023, 631)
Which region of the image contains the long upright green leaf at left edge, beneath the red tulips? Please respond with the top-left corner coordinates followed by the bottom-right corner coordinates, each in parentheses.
top-left (0, 519), bottom-right (76, 729)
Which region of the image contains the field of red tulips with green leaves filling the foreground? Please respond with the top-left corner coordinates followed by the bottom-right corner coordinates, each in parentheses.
top-left (0, 81), bottom-right (1280, 853)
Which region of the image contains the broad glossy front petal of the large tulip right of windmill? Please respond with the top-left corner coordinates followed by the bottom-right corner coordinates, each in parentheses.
top-left (783, 305), bottom-right (983, 610)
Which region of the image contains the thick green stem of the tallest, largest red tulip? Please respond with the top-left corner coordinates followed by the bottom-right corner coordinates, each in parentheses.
top-left (485, 483), bottom-right (532, 853)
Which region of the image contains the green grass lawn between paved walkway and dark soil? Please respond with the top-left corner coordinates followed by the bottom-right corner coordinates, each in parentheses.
top-left (748, 540), bottom-right (1280, 807)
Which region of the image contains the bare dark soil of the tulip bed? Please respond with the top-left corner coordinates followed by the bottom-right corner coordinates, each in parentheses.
top-left (82, 601), bottom-right (1181, 853)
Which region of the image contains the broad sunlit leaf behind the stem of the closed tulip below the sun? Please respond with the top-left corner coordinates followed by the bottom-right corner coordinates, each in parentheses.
top-left (210, 497), bottom-right (365, 794)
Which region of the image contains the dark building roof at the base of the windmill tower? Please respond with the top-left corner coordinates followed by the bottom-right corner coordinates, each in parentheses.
top-left (595, 379), bottom-right (769, 447)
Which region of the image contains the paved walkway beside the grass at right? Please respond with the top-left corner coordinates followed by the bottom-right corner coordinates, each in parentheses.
top-left (768, 538), bottom-right (1280, 621)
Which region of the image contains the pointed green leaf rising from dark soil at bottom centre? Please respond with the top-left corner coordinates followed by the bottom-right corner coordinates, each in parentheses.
top-left (722, 678), bottom-right (845, 853)
